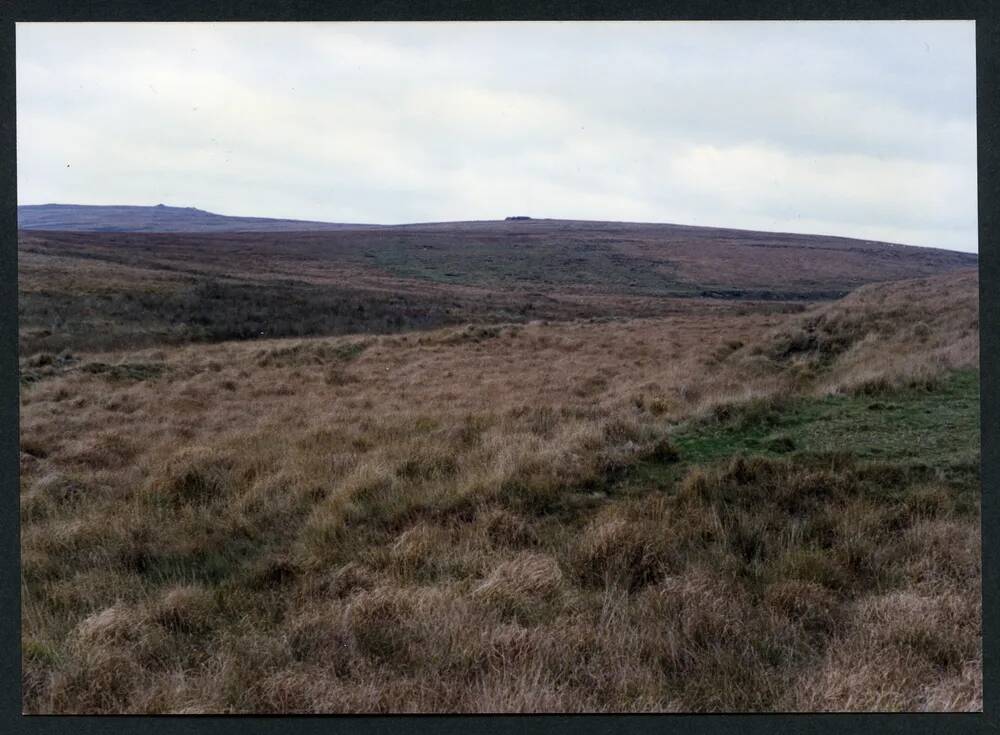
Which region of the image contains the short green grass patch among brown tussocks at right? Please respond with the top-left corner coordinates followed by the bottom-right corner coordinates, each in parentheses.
top-left (618, 370), bottom-right (980, 492)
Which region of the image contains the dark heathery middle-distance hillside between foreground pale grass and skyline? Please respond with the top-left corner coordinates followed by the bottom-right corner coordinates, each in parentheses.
top-left (18, 220), bottom-right (977, 351)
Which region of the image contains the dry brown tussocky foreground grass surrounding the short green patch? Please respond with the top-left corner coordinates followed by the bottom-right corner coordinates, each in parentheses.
top-left (21, 275), bottom-right (982, 712)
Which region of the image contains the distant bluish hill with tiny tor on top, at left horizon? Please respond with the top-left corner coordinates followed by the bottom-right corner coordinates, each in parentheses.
top-left (17, 204), bottom-right (370, 232)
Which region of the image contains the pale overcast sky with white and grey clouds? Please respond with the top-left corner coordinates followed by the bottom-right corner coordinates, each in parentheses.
top-left (17, 21), bottom-right (978, 252)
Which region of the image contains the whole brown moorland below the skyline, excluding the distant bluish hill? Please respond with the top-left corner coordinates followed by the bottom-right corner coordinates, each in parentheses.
top-left (18, 215), bottom-right (982, 713)
